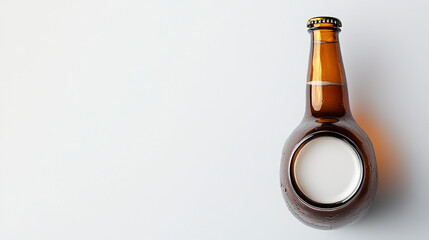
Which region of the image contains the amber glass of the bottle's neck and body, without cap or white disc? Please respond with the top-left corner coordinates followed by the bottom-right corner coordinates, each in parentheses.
top-left (280, 18), bottom-right (377, 229)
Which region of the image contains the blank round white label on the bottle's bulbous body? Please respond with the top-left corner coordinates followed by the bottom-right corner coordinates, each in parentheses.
top-left (293, 136), bottom-right (363, 204)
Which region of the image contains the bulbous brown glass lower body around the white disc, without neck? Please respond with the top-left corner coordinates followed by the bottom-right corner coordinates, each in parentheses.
top-left (280, 118), bottom-right (377, 229)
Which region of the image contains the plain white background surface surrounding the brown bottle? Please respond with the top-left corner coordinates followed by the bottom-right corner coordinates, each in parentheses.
top-left (0, 0), bottom-right (429, 240)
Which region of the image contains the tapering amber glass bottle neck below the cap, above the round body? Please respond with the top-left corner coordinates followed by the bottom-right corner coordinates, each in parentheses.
top-left (306, 28), bottom-right (350, 118)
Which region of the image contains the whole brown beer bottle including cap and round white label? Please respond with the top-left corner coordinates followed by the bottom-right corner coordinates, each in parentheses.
top-left (280, 17), bottom-right (377, 229)
